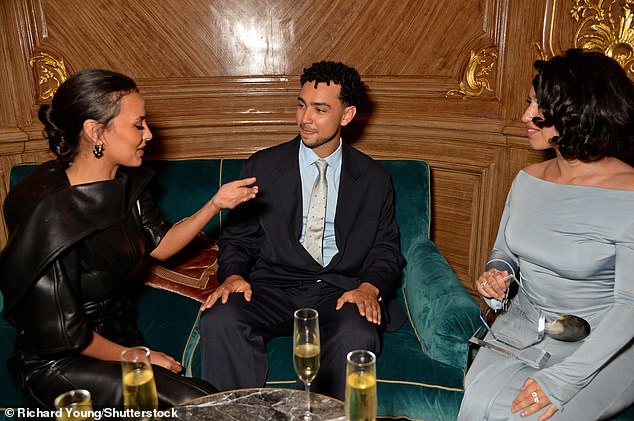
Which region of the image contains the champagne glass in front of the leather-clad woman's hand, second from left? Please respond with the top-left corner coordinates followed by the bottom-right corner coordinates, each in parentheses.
top-left (121, 346), bottom-right (158, 420)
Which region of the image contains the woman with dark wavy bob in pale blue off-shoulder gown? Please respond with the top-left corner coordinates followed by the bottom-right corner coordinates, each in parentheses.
top-left (458, 50), bottom-right (634, 421)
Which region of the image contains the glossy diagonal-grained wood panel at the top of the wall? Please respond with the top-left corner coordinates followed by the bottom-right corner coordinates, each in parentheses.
top-left (33, 0), bottom-right (501, 78)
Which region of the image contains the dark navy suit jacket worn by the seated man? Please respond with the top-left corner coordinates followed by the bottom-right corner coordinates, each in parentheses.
top-left (218, 136), bottom-right (405, 330)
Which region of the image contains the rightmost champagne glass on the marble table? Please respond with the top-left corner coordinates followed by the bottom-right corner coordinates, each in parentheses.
top-left (345, 350), bottom-right (376, 421)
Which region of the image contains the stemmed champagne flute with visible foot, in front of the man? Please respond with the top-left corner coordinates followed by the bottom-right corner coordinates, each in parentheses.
top-left (293, 308), bottom-right (321, 421)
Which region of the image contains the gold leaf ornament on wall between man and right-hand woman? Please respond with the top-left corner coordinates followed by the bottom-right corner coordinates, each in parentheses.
top-left (445, 47), bottom-right (498, 100)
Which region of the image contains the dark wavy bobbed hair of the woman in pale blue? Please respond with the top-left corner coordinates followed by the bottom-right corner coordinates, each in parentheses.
top-left (533, 49), bottom-right (634, 162)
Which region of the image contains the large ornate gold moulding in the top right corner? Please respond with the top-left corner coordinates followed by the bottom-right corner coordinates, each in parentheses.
top-left (533, 0), bottom-right (634, 76)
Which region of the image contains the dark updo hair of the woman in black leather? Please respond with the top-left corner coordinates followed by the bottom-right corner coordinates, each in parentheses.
top-left (38, 69), bottom-right (139, 166)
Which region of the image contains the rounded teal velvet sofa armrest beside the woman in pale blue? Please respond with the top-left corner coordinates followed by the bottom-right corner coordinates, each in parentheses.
top-left (403, 238), bottom-right (480, 370)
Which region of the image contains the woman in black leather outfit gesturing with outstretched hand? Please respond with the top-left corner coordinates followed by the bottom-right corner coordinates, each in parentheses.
top-left (0, 69), bottom-right (257, 409)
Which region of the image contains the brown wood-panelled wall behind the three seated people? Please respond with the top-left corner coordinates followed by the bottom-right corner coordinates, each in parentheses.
top-left (0, 0), bottom-right (624, 302)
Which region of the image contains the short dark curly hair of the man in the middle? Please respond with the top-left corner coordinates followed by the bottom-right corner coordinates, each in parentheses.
top-left (300, 61), bottom-right (368, 107)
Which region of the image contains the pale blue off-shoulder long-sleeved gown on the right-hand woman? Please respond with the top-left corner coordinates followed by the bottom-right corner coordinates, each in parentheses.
top-left (458, 171), bottom-right (634, 421)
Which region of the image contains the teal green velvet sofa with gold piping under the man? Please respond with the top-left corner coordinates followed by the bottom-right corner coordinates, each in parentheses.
top-left (0, 159), bottom-right (628, 420)
